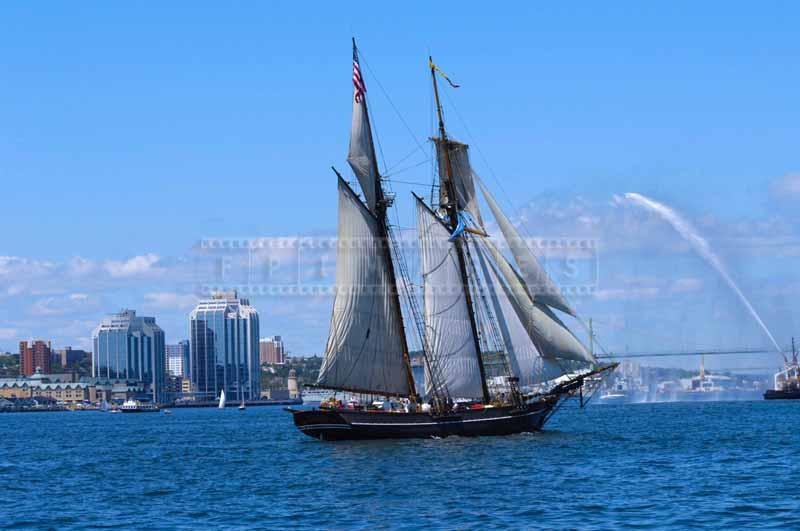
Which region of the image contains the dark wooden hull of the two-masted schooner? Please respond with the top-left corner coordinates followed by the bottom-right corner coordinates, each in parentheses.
top-left (290, 398), bottom-right (558, 441)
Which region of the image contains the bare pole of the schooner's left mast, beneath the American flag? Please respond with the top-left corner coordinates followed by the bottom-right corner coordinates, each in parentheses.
top-left (353, 37), bottom-right (417, 402)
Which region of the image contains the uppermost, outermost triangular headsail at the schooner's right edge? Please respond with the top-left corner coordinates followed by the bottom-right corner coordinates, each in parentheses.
top-left (479, 182), bottom-right (576, 316)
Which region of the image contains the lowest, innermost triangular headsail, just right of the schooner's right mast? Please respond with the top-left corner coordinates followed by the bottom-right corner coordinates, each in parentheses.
top-left (473, 241), bottom-right (566, 386)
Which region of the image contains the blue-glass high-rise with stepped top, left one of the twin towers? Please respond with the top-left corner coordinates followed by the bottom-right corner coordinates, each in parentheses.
top-left (92, 310), bottom-right (166, 402)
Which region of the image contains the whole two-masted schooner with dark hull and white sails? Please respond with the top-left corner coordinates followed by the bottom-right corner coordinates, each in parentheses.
top-left (288, 41), bottom-right (617, 441)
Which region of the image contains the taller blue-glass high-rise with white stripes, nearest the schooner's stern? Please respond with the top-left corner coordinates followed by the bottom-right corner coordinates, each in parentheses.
top-left (189, 291), bottom-right (261, 400)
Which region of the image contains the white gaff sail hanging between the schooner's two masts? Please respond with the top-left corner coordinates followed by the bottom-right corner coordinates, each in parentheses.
top-left (417, 198), bottom-right (483, 398)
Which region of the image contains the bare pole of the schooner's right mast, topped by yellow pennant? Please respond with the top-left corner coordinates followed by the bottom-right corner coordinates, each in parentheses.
top-left (428, 57), bottom-right (490, 404)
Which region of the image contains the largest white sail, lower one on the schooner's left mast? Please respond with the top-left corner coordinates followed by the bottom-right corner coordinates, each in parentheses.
top-left (317, 179), bottom-right (410, 396)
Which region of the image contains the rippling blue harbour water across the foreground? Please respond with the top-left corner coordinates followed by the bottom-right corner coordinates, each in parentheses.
top-left (0, 401), bottom-right (800, 530)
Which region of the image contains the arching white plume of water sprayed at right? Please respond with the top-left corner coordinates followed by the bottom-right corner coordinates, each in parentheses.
top-left (625, 193), bottom-right (782, 352)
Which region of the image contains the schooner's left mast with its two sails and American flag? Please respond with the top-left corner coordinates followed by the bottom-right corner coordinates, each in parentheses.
top-left (317, 39), bottom-right (418, 402)
